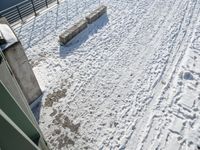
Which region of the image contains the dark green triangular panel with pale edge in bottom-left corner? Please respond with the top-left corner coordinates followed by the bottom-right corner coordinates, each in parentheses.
top-left (0, 109), bottom-right (39, 150)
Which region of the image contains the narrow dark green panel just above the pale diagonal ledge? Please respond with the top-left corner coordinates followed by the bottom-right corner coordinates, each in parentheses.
top-left (0, 81), bottom-right (40, 144)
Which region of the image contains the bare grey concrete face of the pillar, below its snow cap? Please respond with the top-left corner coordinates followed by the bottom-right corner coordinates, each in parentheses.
top-left (3, 42), bottom-right (42, 104)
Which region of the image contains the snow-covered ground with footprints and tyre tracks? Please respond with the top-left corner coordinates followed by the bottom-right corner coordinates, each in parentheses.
top-left (15, 0), bottom-right (200, 150)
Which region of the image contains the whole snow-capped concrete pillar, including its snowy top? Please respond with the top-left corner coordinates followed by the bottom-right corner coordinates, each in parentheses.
top-left (0, 19), bottom-right (42, 104)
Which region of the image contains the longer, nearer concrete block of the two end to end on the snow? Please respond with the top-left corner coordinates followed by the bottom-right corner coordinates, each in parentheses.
top-left (59, 19), bottom-right (87, 45)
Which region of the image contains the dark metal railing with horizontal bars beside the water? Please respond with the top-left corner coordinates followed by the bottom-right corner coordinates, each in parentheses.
top-left (0, 0), bottom-right (59, 24)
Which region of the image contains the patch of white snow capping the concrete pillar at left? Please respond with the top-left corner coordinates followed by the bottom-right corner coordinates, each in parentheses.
top-left (0, 24), bottom-right (18, 50)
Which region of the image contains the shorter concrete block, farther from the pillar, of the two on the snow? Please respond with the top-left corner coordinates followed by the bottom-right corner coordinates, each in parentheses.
top-left (85, 5), bottom-right (107, 24)
